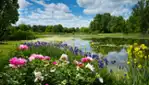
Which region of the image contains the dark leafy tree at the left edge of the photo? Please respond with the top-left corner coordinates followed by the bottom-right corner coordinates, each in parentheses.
top-left (0, 0), bottom-right (19, 40)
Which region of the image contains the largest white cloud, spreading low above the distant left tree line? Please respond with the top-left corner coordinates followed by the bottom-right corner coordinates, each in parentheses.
top-left (16, 1), bottom-right (91, 27)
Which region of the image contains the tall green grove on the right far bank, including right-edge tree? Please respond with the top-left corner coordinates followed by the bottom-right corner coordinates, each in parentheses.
top-left (89, 0), bottom-right (149, 34)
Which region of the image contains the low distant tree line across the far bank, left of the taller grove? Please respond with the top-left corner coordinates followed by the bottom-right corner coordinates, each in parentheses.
top-left (9, 24), bottom-right (89, 33)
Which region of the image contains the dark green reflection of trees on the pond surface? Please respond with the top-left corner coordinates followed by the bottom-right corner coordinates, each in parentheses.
top-left (91, 38), bottom-right (149, 54)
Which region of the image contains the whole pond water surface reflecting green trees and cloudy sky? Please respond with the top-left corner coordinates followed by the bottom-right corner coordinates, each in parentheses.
top-left (63, 38), bottom-right (149, 71)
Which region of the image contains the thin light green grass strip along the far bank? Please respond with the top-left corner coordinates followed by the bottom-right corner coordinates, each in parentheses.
top-left (38, 33), bottom-right (149, 39)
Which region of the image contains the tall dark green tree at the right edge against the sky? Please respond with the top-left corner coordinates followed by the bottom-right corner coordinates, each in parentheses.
top-left (128, 0), bottom-right (149, 34)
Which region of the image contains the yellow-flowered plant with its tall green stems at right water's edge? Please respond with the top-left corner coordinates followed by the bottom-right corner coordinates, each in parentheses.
top-left (126, 43), bottom-right (149, 85)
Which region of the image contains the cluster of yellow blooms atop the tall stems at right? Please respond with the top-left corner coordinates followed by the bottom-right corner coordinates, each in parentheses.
top-left (127, 43), bottom-right (149, 68)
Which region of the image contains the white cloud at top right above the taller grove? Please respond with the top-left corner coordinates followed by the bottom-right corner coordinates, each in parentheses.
top-left (77, 0), bottom-right (138, 16)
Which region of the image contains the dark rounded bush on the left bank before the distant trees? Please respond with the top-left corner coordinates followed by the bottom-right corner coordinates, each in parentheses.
top-left (8, 30), bottom-right (36, 40)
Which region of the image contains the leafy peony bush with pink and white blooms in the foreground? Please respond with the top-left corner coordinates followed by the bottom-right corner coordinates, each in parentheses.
top-left (0, 43), bottom-right (116, 85)
